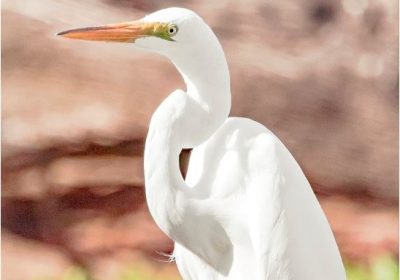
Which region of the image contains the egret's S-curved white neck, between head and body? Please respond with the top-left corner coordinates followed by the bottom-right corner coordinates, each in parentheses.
top-left (144, 40), bottom-right (231, 238)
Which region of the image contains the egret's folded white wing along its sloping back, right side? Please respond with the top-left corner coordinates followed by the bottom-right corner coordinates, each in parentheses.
top-left (246, 128), bottom-right (346, 280)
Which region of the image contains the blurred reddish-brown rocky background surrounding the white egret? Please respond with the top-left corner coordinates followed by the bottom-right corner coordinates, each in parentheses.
top-left (1, 0), bottom-right (399, 280)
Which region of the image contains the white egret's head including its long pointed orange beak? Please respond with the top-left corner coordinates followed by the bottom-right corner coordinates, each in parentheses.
top-left (58, 8), bottom-right (206, 56)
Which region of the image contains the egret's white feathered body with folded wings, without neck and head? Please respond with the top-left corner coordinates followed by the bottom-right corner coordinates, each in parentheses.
top-left (149, 114), bottom-right (345, 280)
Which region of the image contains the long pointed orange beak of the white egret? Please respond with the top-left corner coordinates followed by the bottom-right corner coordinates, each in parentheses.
top-left (57, 21), bottom-right (154, 43)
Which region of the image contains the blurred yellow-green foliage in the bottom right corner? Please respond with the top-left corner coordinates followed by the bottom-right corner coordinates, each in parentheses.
top-left (346, 256), bottom-right (399, 280)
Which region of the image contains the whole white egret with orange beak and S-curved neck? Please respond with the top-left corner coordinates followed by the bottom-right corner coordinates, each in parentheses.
top-left (60, 8), bottom-right (345, 280)
